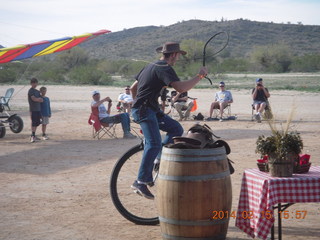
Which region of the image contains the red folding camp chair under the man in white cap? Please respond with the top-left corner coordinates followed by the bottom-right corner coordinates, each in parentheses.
top-left (88, 107), bottom-right (117, 139)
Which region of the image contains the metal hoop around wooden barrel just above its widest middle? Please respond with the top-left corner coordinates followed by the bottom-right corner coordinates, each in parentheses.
top-left (158, 170), bottom-right (230, 182)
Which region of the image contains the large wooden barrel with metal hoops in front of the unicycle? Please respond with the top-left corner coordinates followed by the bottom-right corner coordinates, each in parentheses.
top-left (156, 147), bottom-right (232, 240)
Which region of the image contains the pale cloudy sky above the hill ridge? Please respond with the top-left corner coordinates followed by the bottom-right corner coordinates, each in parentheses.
top-left (0, 0), bottom-right (320, 47)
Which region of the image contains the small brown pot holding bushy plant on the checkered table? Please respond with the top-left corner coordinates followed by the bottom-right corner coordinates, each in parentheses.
top-left (268, 154), bottom-right (296, 177)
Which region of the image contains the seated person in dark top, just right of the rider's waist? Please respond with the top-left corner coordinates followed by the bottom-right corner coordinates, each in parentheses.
top-left (171, 91), bottom-right (193, 121)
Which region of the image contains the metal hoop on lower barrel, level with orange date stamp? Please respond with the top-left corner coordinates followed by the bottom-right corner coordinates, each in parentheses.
top-left (159, 216), bottom-right (229, 226)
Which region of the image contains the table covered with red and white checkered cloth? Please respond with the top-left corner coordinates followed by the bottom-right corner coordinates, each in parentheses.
top-left (236, 166), bottom-right (320, 239)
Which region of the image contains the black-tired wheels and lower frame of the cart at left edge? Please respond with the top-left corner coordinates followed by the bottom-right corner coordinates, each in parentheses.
top-left (0, 103), bottom-right (23, 138)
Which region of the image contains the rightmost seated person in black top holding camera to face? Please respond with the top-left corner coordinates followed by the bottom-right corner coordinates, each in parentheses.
top-left (252, 78), bottom-right (270, 122)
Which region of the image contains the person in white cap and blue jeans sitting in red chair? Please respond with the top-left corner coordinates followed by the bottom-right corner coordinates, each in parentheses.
top-left (91, 90), bottom-right (136, 138)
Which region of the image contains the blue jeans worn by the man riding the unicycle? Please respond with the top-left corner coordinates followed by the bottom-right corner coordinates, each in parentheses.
top-left (132, 107), bottom-right (183, 183)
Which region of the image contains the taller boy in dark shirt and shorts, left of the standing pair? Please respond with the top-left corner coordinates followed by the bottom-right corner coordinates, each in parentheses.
top-left (28, 78), bottom-right (43, 143)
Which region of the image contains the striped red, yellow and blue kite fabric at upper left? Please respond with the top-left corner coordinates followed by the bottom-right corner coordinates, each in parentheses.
top-left (0, 30), bottom-right (110, 64)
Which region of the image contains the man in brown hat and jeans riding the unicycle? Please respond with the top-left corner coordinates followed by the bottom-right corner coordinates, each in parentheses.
top-left (131, 42), bottom-right (208, 199)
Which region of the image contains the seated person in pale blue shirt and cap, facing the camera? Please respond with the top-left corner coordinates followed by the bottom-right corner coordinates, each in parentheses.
top-left (207, 82), bottom-right (233, 122)
